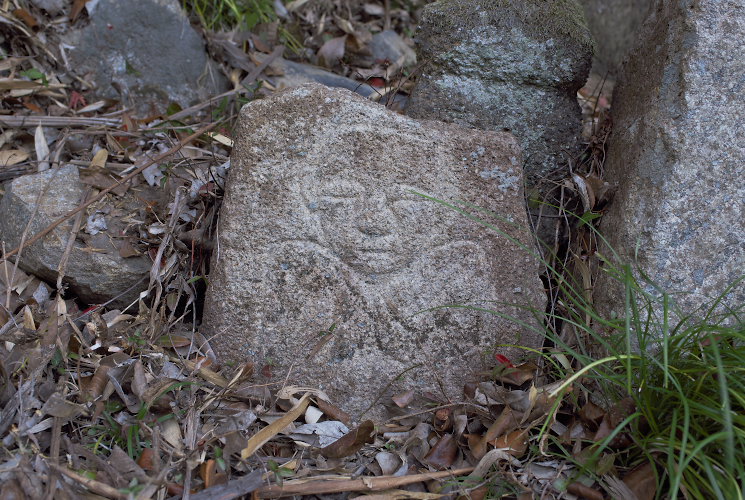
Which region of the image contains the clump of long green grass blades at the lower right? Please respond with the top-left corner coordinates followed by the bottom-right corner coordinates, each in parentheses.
top-left (552, 268), bottom-right (745, 499)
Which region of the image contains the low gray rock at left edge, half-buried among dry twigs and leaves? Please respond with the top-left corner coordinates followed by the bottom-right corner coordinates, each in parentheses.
top-left (0, 165), bottom-right (150, 307)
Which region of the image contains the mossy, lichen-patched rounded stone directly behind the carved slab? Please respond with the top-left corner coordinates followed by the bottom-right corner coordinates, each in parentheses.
top-left (407, 0), bottom-right (593, 184)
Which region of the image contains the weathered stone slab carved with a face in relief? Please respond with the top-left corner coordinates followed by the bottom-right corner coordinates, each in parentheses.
top-left (203, 84), bottom-right (545, 418)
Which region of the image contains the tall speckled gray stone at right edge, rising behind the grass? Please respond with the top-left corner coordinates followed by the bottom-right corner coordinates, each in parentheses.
top-left (596, 0), bottom-right (745, 332)
